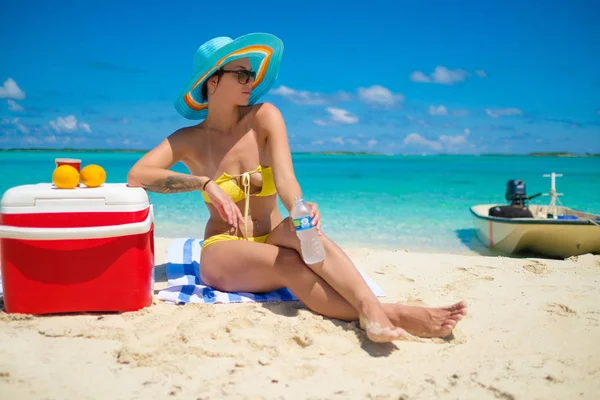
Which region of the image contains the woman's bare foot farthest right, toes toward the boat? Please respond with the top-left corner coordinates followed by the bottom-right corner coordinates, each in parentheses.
top-left (385, 301), bottom-right (467, 338)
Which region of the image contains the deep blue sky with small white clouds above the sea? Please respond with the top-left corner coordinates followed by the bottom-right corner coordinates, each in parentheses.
top-left (0, 0), bottom-right (600, 154)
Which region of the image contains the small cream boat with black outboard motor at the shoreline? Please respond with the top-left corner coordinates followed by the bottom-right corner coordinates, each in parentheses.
top-left (470, 172), bottom-right (600, 258)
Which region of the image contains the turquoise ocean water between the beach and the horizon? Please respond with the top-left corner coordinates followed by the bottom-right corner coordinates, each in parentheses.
top-left (0, 151), bottom-right (600, 254)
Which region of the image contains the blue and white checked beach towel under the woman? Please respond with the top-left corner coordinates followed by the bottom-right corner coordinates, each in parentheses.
top-left (157, 238), bottom-right (385, 304)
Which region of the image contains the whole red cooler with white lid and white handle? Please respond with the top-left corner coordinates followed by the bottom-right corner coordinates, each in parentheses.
top-left (0, 183), bottom-right (154, 314)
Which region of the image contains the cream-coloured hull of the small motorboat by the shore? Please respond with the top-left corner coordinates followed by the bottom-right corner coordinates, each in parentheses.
top-left (470, 204), bottom-right (600, 258)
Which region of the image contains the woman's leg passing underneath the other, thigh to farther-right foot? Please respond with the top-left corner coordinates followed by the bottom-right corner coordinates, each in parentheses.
top-left (201, 224), bottom-right (466, 337)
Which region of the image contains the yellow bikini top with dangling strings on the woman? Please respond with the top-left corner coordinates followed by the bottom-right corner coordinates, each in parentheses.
top-left (202, 165), bottom-right (277, 237)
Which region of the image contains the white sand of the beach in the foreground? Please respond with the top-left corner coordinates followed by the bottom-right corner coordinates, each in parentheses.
top-left (0, 239), bottom-right (600, 400)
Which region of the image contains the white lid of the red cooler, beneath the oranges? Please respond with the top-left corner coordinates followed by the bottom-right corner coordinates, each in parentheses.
top-left (0, 183), bottom-right (150, 214)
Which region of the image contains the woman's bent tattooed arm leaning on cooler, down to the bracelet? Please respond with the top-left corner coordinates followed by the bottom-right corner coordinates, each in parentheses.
top-left (127, 128), bottom-right (209, 193)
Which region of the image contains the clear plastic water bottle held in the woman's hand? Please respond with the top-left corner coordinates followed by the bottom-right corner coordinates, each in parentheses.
top-left (290, 198), bottom-right (325, 265)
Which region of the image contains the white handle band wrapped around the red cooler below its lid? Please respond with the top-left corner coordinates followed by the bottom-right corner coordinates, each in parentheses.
top-left (0, 205), bottom-right (154, 240)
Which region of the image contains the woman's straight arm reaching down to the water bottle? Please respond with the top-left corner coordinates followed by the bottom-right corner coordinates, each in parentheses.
top-left (255, 103), bottom-right (302, 212)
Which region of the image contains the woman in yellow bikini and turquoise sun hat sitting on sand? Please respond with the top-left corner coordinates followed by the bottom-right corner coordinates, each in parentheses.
top-left (128, 34), bottom-right (466, 342)
